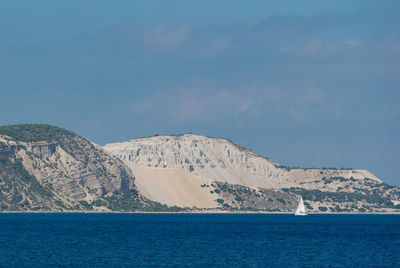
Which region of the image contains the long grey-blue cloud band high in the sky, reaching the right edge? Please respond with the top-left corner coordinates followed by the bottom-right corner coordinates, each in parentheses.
top-left (76, 12), bottom-right (400, 67)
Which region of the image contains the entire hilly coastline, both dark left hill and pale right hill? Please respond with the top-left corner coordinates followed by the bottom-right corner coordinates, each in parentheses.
top-left (0, 124), bottom-right (400, 213)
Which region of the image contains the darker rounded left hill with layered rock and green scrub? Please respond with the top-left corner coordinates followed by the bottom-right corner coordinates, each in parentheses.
top-left (0, 125), bottom-right (156, 211)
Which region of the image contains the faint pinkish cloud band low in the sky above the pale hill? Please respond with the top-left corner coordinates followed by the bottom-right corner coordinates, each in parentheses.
top-left (132, 79), bottom-right (343, 123)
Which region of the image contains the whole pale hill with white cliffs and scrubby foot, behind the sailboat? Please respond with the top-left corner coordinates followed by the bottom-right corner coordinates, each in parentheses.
top-left (103, 134), bottom-right (400, 212)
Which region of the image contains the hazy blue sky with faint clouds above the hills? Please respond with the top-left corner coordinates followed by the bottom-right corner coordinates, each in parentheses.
top-left (0, 0), bottom-right (400, 186)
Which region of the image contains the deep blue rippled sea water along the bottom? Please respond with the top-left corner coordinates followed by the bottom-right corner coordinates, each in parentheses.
top-left (0, 214), bottom-right (400, 267)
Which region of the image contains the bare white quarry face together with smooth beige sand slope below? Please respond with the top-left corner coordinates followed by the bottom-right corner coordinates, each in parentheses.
top-left (103, 134), bottom-right (381, 208)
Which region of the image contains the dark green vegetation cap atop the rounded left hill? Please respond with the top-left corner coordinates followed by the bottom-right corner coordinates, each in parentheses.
top-left (0, 124), bottom-right (77, 142)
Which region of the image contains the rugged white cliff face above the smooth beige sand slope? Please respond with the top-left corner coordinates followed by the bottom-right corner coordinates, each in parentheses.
top-left (103, 134), bottom-right (380, 191)
